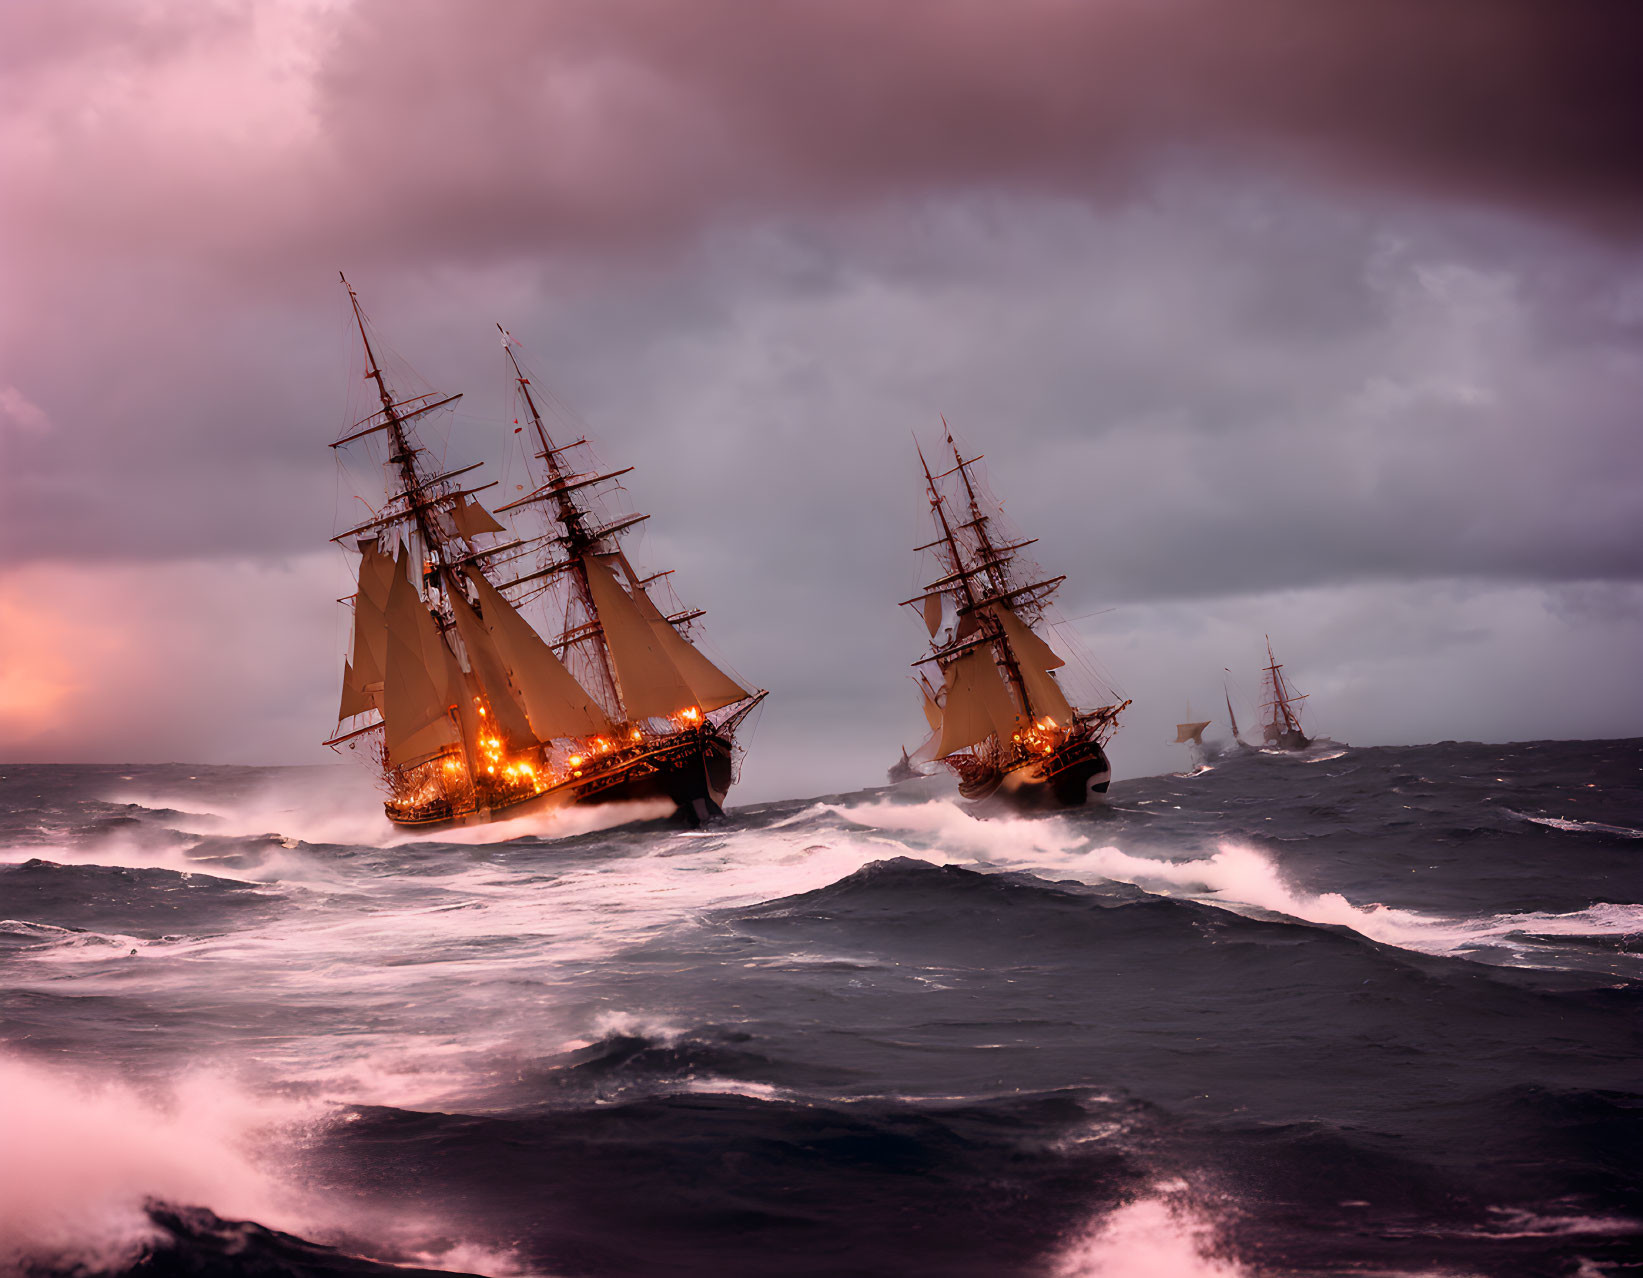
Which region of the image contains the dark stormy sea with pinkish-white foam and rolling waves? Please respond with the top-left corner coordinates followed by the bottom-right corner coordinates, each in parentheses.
top-left (0, 741), bottom-right (1643, 1278)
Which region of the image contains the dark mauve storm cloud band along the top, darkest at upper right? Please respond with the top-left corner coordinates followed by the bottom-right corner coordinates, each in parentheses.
top-left (299, 0), bottom-right (1643, 251)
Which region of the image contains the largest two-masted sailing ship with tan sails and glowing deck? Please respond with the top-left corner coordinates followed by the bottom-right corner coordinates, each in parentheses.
top-left (327, 279), bottom-right (766, 830)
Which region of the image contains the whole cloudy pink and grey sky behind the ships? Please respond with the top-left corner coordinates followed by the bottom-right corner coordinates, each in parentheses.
top-left (0, 0), bottom-right (1643, 800)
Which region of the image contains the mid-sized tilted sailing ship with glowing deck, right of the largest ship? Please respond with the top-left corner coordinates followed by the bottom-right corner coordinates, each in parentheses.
top-left (902, 419), bottom-right (1129, 808)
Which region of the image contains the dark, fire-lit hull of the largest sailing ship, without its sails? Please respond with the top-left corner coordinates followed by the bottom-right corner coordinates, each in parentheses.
top-left (384, 733), bottom-right (734, 830)
